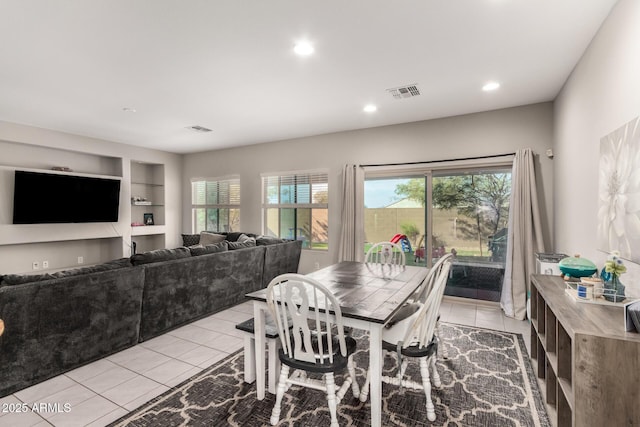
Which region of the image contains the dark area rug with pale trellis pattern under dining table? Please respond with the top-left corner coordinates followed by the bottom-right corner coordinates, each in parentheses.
top-left (111, 324), bottom-right (550, 427)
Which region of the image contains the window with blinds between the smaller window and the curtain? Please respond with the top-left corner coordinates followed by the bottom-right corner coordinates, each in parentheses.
top-left (262, 171), bottom-right (329, 250)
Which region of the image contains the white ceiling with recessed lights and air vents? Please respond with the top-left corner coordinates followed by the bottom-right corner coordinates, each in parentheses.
top-left (0, 0), bottom-right (616, 153)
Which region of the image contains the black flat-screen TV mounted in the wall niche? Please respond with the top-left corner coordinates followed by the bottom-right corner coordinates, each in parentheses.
top-left (13, 170), bottom-right (120, 224)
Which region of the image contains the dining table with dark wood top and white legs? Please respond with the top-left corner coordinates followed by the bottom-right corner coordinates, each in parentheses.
top-left (247, 261), bottom-right (429, 426)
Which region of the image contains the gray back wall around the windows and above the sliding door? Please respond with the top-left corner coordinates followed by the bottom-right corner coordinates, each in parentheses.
top-left (182, 103), bottom-right (554, 272)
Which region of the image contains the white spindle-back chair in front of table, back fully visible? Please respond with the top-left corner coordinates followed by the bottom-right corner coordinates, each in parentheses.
top-left (266, 273), bottom-right (360, 427)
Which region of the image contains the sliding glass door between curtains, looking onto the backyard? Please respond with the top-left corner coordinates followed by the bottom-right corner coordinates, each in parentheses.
top-left (364, 167), bottom-right (511, 301)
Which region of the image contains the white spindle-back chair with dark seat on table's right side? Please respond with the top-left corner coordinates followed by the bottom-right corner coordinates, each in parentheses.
top-left (360, 254), bottom-right (453, 421)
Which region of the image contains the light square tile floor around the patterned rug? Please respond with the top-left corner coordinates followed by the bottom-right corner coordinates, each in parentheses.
top-left (0, 297), bottom-right (529, 427)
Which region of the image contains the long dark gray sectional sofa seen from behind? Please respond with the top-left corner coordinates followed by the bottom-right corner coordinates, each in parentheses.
top-left (0, 239), bottom-right (302, 397)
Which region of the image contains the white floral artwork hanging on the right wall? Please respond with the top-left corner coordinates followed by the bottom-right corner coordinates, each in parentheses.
top-left (598, 117), bottom-right (640, 262)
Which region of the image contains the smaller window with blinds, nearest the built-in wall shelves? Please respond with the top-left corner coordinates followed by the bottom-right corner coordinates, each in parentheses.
top-left (191, 177), bottom-right (240, 233)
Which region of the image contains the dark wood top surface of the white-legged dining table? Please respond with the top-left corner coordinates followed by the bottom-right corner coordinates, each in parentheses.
top-left (247, 261), bottom-right (429, 324)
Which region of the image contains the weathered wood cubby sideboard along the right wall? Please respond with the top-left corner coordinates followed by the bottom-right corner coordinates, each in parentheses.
top-left (531, 275), bottom-right (640, 427)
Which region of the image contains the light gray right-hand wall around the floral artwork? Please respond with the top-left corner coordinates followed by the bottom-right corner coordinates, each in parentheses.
top-left (554, 0), bottom-right (640, 296)
